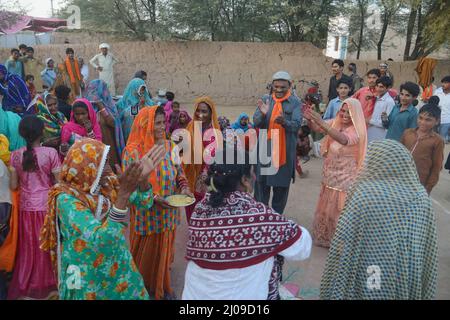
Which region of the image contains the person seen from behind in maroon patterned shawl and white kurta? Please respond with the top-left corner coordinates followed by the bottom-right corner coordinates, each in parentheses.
top-left (183, 147), bottom-right (312, 300)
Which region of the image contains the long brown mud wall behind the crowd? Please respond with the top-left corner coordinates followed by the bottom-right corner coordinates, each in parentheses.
top-left (0, 39), bottom-right (450, 106)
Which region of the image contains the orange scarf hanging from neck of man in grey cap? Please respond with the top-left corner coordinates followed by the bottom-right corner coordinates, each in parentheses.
top-left (267, 91), bottom-right (291, 168)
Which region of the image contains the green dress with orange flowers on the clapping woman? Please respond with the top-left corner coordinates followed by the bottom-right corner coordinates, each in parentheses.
top-left (57, 190), bottom-right (153, 300)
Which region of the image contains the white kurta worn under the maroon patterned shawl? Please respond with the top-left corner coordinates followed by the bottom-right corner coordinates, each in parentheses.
top-left (182, 227), bottom-right (312, 300)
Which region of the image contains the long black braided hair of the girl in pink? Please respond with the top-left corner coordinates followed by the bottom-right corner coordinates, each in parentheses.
top-left (19, 115), bottom-right (44, 172)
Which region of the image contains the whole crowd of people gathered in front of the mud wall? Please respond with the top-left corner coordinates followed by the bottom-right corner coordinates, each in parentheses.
top-left (0, 44), bottom-right (450, 300)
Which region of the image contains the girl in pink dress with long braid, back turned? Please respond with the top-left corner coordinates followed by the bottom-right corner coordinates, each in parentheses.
top-left (8, 116), bottom-right (61, 300)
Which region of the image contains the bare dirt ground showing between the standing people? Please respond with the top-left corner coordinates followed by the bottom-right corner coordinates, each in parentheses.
top-left (172, 106), bottom-right (450, 300)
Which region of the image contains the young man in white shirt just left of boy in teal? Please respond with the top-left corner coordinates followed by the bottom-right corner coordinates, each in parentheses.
top-left (367, 76), bottom-right (395, 143)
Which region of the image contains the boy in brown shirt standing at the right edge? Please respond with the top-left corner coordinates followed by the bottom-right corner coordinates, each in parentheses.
top-left (400, 99), bottom-right (444, 194)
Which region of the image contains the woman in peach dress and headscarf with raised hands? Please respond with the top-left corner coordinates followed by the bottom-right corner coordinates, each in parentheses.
top-left (304, 98), bottom-right (367, 248)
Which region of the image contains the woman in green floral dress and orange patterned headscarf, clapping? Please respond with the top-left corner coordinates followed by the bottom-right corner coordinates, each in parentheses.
top-left (40, 139), bottom-right (165, 300)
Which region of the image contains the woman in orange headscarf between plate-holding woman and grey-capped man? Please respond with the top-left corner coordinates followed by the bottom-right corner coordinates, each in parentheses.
top-left (183, 97), bottom-right (223, 222)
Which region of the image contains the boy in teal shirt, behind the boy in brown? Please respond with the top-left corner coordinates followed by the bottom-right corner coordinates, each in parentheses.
top-left (381, 82), bottom-right (420, 141)
